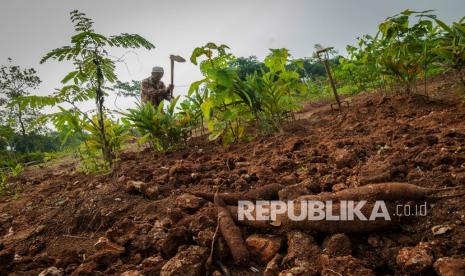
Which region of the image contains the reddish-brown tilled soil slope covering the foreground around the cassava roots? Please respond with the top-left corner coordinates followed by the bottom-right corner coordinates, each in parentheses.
top-left (0, 85), bottom-right (465, 275)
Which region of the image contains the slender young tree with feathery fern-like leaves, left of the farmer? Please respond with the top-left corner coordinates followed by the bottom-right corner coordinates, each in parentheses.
top-left (23, 10), bottom-right (155, 168)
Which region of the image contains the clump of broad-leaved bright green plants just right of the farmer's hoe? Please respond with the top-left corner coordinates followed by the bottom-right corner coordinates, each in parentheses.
top-left (189, 43), bottom-right (307, 143)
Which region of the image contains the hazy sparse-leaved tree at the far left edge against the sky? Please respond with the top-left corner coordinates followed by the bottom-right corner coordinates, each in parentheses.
top-left (0, 58), bottom-right (41, 137)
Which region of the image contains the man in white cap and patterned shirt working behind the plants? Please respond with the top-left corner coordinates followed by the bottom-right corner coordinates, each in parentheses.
top-left (140, 66), bottom-right (174, 107)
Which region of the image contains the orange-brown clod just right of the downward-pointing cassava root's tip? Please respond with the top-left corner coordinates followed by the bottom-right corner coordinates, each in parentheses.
top-left (245, 234), bottom-right (282, 264)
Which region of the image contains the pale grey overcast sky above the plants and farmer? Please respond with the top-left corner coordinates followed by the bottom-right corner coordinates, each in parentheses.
top-left (0, 0), bottom-right (465, 113)
